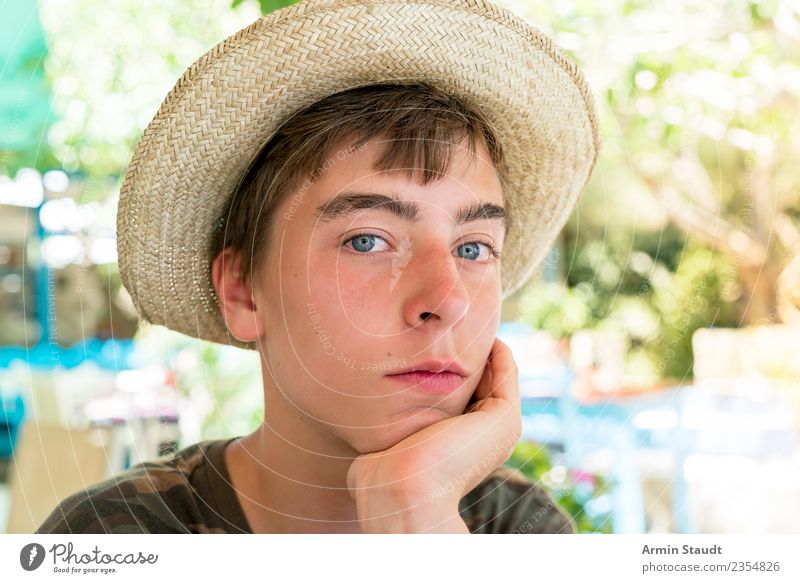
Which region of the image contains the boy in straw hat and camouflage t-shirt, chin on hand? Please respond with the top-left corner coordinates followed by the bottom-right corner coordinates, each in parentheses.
top-left (37, 0), bottom-right (599, 533)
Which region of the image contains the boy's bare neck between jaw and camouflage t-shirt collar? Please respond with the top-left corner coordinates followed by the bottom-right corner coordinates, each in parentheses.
top-left (226, 374), bottom-right (360, 533)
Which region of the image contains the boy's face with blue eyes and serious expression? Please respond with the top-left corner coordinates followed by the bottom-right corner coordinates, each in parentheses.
top-left (245, 138), bottom-right (504, 453)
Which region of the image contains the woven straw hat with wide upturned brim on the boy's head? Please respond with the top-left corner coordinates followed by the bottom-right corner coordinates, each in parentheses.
top-left (117, 0), bottom-right (600, 349)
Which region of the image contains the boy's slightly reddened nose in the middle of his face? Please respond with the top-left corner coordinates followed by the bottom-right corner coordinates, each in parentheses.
top-left (403, 244), bottom-right (470, 329)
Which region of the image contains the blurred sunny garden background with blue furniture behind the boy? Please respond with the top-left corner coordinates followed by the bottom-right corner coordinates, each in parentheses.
top-left (0, 0), bottom-right (800, 533)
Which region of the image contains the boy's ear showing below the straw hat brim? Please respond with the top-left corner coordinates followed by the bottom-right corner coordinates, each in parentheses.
top-left (211, 247), bottom-right (264, 342)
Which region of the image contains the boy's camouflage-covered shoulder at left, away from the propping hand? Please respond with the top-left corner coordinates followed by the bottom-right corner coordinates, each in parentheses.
top-left (36, 441), bottom-right (227, 534)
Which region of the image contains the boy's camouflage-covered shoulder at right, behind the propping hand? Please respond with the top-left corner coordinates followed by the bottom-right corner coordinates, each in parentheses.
top-left (459, 465), bottom-right (577, 534)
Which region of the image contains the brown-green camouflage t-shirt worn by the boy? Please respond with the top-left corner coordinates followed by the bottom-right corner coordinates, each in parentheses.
top-left (36, 437), bottom-right (576, 534)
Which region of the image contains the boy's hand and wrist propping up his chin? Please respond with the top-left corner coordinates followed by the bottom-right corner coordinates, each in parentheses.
top-left (347, 339), bottom-right (522, 532)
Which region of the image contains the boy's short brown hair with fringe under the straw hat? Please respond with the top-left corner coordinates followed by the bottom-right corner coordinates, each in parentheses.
top-left (209, 82), bottom-right (507, 290)
